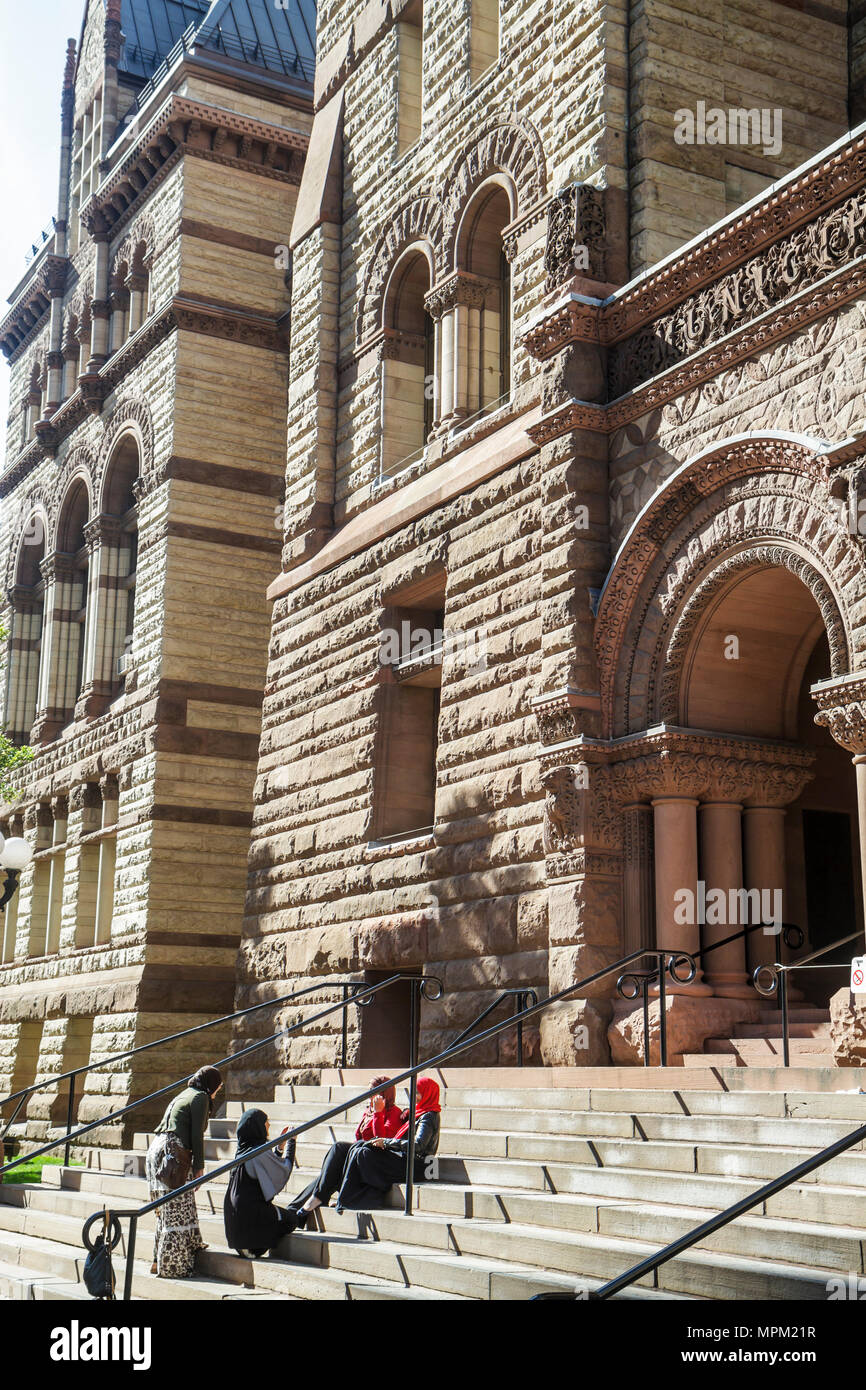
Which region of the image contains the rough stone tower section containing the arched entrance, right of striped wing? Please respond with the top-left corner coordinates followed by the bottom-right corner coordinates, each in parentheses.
top-left (238, 0), bottom-right (866, 1090)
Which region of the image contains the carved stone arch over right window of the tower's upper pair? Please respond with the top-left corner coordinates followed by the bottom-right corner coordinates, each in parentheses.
top-left (436, 117), bottom-right (548, 275)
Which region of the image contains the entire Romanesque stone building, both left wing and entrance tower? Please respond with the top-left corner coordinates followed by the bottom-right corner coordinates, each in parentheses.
top-left (8, 0), bottom-right (866, 1117)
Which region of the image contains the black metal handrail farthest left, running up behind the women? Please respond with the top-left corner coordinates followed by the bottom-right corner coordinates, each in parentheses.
top-left (0, 973), bottom-right (419, 1179)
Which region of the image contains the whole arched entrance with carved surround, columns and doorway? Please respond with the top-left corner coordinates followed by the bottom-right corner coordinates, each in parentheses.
top-left (575, 435), bottom-right (866, 1051)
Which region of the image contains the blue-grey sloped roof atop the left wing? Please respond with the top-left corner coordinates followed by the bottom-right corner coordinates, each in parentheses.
top-left (121, 0), bottom-right (316, 79)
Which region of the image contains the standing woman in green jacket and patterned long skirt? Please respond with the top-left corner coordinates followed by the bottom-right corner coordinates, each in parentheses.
top-left (146, 1066), bottom-right (222, 1279)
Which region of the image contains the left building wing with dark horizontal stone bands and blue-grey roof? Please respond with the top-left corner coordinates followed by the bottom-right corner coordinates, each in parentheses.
top-left (0, 0), bottom-right (314, 1143)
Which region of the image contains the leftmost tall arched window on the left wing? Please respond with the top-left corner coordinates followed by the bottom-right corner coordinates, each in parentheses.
top-left (6, 512), bottom-right (46, 744)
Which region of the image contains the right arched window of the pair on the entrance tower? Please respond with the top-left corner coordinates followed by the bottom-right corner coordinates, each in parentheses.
top-left (457, 183), bottom-right (513, 414)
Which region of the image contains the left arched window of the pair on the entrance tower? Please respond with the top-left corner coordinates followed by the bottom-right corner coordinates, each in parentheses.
top-left (382, 249), bottom-right (435, 473)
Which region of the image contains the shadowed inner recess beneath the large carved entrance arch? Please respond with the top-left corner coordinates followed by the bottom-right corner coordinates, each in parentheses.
top-left (676, 564), bottom-right (863, 1005)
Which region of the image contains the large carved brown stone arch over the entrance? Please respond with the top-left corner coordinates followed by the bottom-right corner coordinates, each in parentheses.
top-left (595, 434), bottom-right (866, 737)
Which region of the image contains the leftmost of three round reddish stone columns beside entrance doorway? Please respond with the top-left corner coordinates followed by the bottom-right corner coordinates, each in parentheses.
top-left (652, 796), bottom-right (713, 994)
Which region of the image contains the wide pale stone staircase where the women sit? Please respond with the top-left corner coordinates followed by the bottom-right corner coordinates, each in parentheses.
top-left (0, 1058), bottom-right (866, 1301)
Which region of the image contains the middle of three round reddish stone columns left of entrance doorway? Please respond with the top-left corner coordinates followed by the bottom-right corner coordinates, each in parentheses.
top-left (701, 801), bottom-right (753, 999)
